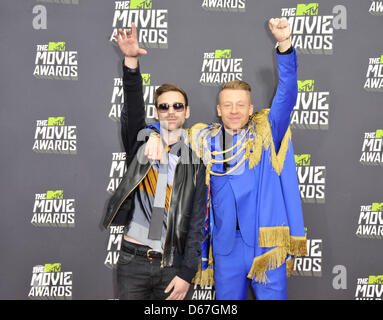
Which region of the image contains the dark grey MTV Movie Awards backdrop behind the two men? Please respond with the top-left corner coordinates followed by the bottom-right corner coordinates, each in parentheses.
top-left (0, 0), bottom-right (383, 300)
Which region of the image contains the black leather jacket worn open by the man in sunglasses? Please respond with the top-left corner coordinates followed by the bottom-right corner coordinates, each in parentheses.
top-left (103, 65), bottom-right (207, 282)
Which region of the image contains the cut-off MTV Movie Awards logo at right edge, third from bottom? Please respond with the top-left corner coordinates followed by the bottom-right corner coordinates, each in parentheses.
top-left (359, 129), bottom-right (383, 165)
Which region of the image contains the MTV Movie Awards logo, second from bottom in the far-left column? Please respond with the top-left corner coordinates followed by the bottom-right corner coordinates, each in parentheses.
top-left (31, 190), bottom-right (76, 227)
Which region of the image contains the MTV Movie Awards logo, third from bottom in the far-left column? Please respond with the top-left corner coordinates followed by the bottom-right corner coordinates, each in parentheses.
top-left (32, 117), bottom-right (77, 154)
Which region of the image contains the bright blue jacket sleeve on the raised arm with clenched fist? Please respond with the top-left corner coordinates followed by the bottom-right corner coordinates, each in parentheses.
top-left (269, 48), bottom-right (298, 152)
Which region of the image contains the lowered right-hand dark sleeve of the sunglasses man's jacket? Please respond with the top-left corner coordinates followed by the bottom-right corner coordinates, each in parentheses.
top-left (177, 163), bottom-right (207, 283)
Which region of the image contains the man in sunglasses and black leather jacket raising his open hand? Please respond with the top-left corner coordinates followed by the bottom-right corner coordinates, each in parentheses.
top-left (103, 24), bottom-right (207, 300)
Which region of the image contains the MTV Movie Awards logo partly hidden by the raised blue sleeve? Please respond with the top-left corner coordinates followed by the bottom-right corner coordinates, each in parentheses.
top-left (290, 80), bottom-right (330, 130)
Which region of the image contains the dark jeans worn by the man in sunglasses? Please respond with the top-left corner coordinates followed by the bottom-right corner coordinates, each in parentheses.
top-left (117, 240), bottom-right (177, 300)
